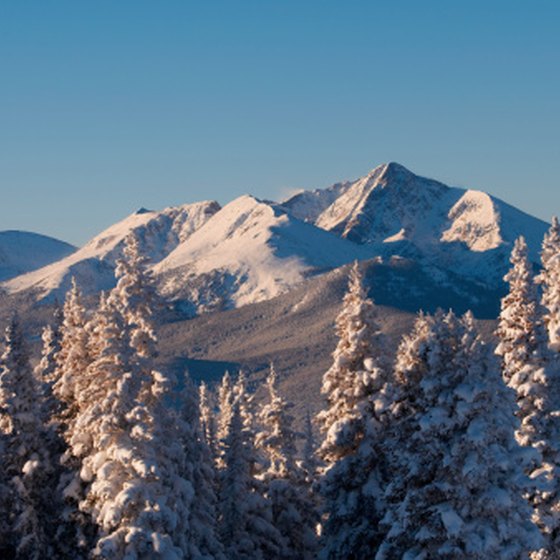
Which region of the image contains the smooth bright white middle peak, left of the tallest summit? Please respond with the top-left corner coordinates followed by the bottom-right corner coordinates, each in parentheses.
top-left (154, 196), bottom-right (367, 308)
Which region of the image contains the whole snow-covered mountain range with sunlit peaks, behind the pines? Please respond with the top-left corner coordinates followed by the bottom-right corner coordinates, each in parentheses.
top-left (2, 163), bottom-right (548, 311)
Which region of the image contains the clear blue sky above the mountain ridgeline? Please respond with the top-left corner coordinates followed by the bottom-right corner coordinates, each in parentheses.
top-left (0, 0), bottom-right (560, 244)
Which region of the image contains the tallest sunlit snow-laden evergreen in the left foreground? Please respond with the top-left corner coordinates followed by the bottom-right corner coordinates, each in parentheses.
top-left (66, 238), bottom-right (221, 560)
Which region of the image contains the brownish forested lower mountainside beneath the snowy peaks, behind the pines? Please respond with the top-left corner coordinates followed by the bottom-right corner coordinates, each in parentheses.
top-left (159, 259), bottom-right (497, 420)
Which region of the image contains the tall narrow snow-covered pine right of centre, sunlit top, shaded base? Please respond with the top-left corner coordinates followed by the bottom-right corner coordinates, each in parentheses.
top-left (318, 263), bottom-right (390, 559)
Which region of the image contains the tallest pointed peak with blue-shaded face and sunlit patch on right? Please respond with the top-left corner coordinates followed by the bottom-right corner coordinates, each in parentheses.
top-left (285, 163), bottom-right (548, 283)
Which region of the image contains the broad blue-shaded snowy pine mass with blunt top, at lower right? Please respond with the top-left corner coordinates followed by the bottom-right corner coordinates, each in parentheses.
top-left (375, 312), bottom-right (540, 560)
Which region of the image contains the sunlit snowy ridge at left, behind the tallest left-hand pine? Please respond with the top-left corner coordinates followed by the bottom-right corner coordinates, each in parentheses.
top-left (2, 201), bottom-right (220, 297)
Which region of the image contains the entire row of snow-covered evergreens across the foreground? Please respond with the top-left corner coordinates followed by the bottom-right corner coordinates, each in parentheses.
top-left (0, 219), bottom-right (560, 560)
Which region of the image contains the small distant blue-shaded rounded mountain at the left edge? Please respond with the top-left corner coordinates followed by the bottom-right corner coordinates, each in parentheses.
top-left (0, 231), bottom-right (76, 281)
